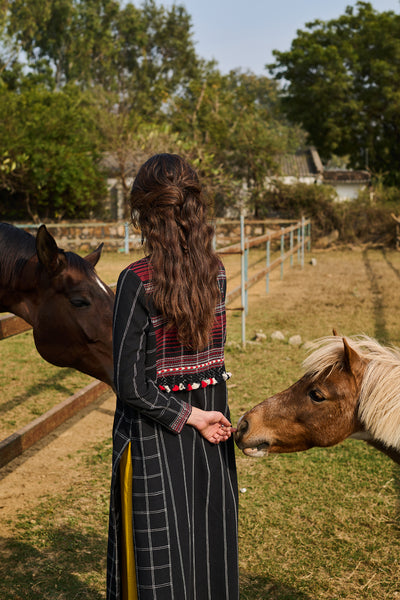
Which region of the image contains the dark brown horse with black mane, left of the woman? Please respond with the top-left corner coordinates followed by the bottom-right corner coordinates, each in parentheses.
top-left (0, 223), bottom-right (114, 385)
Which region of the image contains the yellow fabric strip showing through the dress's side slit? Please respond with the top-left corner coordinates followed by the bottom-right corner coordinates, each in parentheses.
top-left (119, 442), bottom-right (138, 600)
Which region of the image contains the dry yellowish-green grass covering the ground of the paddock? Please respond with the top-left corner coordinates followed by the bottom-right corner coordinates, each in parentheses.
top-left (0, 248), bottom-right (400, 600)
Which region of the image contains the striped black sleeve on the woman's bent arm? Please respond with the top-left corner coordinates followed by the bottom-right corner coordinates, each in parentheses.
top-left (113, 269), bottom-right (191, 433)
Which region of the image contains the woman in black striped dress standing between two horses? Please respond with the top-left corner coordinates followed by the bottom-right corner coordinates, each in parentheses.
top-left (107, 154), bottom-right (238, 600)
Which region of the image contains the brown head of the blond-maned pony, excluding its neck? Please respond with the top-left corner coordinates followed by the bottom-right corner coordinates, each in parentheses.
top-left (235, 337), bottom-right (365, 456)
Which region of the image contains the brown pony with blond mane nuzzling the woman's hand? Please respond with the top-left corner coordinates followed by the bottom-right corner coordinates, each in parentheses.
top-left (235, 336), bottom-right (400, 463)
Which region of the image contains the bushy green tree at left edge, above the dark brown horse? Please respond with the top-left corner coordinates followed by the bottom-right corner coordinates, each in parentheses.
top-left (0, 86), bottom-right (105, 221)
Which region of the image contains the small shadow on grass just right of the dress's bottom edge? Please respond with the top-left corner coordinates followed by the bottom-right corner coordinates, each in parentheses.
top-left (240, 573), bottom-right (311, 600)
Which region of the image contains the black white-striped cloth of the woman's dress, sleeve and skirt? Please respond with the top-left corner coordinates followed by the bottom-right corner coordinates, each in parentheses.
top-left (107, 264), bottom-right (238, 600)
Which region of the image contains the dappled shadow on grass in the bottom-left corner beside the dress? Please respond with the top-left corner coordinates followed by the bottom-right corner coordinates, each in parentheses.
top-left (0, 525), bottom-right (107, 600)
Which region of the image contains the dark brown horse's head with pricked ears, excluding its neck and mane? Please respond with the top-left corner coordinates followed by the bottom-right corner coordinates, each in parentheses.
top-left (28, 225), bottom-right (114, 385)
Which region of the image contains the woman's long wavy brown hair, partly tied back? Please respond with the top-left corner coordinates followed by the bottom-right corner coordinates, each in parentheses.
top-left (130, 154), bottom-right (221, 350)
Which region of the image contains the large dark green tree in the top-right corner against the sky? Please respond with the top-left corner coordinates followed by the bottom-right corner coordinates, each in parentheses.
top-left (269, 2), bottom-right (400, 182)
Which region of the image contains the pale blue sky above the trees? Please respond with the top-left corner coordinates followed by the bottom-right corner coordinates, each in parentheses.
top-left (156, 0), bottom-right (400, 75)
